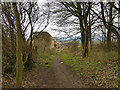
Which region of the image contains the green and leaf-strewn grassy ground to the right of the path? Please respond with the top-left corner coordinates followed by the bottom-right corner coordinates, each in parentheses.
top-left (61, 46), bottom-right (118, 88)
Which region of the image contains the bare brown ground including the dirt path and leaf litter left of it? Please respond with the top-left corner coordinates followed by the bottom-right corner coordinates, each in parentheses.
top-left (3, 55), bottom-right (97, 88)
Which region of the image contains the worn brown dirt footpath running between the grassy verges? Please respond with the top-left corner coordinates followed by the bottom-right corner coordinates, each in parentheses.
top-left (46, 56), bottom-right (86, 88)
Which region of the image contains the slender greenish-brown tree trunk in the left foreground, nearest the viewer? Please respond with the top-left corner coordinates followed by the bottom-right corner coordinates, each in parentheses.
top-left (12, 2), bottom-right (23, 88)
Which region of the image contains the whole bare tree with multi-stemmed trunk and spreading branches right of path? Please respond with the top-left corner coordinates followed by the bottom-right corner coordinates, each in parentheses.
top-left (55, 2), bottom-right (93, 57)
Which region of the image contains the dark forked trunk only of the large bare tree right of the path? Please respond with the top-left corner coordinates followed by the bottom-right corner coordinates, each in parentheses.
top-left (77, 2), bottom-right (91, 58)
